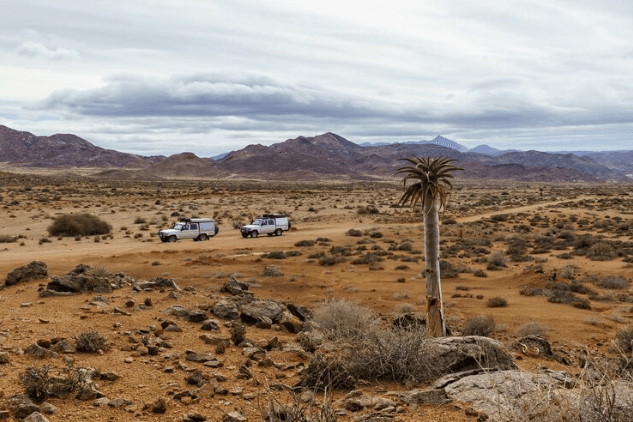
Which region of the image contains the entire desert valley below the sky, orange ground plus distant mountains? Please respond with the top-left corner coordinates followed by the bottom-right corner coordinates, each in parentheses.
top-left (0, 127), bottom-right (633, 422)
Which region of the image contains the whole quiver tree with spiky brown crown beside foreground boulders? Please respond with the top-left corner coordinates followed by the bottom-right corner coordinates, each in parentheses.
top-left (396, 156), bottom-right (463, 337)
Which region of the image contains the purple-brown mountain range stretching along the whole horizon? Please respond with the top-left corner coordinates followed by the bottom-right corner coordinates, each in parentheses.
top-left (0, 125), bottom-right (633, 182)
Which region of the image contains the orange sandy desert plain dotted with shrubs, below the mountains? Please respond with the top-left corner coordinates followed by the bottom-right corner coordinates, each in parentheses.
top-left (0, 172), bottom-right (633, 422)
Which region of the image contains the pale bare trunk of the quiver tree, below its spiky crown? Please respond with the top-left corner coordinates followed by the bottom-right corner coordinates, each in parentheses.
top-left (424, 191), bottom-right (446, 337)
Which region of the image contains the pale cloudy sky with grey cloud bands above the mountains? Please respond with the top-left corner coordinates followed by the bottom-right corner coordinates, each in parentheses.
top-left (0, 0), bottom-right (633, 156)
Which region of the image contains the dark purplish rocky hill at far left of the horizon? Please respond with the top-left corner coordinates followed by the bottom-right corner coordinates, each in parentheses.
top-left (0, 125), bottom-right (164, 167)
